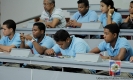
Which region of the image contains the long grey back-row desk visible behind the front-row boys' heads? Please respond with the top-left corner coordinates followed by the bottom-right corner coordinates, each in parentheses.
top-left (16, 28), bottom-right (133, 36)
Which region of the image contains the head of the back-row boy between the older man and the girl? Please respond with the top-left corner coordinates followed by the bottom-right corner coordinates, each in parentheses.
top-left (77, 0), bottom-right (89, 15)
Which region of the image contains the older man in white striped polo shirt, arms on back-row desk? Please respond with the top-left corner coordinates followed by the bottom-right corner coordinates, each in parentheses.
top-left (40, 0), bottom-right (66, 28)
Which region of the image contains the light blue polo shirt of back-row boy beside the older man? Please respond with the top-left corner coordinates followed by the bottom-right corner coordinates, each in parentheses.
top-left (71, 10), bottom-right (98, 23)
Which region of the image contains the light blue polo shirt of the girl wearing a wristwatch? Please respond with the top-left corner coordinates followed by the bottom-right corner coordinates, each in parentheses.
top-left (98, 12), bottom-right (122, 27)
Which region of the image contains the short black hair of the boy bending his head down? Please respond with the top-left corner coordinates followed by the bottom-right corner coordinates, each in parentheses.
top-left (54, 29), bottom-right (70, 42)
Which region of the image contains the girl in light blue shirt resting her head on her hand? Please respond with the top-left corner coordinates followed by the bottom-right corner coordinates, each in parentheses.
top-left (98, 0), bottom-right (122, 27)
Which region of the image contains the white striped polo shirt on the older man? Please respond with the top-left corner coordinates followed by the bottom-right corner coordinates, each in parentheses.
top-left (40, 8), bottom-right (66, 28)
